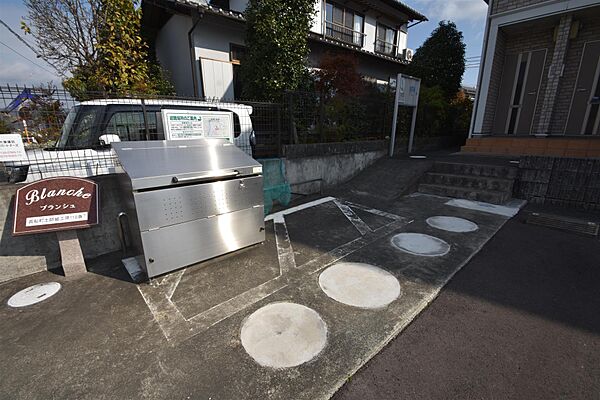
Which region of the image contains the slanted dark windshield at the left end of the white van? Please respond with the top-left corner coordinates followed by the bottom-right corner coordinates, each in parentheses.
top-left (56, 106), bottom-right (102, 149)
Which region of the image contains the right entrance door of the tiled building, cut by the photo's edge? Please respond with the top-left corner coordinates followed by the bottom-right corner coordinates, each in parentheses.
top-left (565, 41), bottom-right (600, 135)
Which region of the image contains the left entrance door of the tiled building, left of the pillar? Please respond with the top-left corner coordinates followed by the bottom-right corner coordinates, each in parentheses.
top-left (494, 49), bottom-right (546, 135)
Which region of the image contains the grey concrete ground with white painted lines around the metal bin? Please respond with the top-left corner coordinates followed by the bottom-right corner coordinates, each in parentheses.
top-left (0, 189), bottom-right (509, 399)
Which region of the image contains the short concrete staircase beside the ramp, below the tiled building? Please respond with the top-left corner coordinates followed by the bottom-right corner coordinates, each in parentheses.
top-left (419, 161), bottom-right (518, 204)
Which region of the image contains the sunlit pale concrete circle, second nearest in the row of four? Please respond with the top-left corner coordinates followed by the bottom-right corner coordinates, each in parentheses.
top-left (319, 262), bottom-right (400, 308)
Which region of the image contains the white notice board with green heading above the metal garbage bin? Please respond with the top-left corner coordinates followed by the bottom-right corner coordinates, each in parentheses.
top-left (161, 110), bottom-right (234, 143)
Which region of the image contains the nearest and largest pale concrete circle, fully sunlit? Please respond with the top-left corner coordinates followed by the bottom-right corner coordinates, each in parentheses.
top-left (241, 302), bottom-right (327, 368)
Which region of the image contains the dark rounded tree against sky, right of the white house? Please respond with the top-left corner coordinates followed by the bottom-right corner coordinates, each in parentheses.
top-left (406, 21), bottom-right (465, 100)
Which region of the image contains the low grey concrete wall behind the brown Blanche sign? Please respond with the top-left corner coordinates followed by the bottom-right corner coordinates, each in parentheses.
top-left (0, 175), bottom-right (121, 282)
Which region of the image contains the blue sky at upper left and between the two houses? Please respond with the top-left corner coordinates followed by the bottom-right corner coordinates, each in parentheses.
top-left (0, 0), bottom-right (487, 86)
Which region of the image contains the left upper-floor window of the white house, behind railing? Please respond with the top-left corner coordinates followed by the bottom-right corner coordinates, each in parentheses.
top-left (325, 2), bottom-right (365, 47)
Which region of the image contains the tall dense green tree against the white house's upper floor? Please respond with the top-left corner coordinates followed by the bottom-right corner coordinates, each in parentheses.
top-left (241, 0), bottom-right (314, 100)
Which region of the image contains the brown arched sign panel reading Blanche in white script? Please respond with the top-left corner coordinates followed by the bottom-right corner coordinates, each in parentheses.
top-left (13, 177), bottom-right (98, 235)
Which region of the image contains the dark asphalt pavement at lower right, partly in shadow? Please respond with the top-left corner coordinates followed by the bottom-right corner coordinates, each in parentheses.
top-left (334, 211), bottom-right (600, 400)
